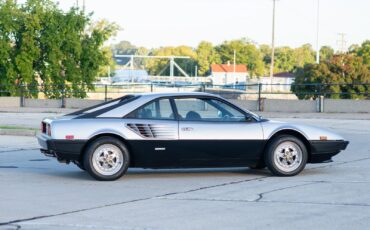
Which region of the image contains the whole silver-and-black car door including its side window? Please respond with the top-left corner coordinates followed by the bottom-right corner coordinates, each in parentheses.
top-left (174, 97), bottom-right (264, 166)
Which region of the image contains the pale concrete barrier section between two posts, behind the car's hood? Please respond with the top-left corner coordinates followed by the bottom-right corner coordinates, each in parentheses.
top-left (263, 99), bottom-right (317, 113)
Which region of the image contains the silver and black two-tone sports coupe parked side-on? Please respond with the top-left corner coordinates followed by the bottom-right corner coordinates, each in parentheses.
top-left (38, 93), bottom-right (348, 180)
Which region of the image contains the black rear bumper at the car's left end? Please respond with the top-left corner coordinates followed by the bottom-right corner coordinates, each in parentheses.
top-left (37, 134), bottom-right (86, 161)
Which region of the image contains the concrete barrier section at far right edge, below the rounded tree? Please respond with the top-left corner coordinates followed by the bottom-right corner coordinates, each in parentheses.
top-left (324, 99), bottom-right (370, 113)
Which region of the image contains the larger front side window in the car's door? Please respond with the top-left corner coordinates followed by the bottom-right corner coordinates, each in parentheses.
top-left (175, 98), bottom-right (245, 121)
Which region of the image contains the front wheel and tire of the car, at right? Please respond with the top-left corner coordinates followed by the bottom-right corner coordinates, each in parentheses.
top-left (265, 135), bottom-right (308, 176)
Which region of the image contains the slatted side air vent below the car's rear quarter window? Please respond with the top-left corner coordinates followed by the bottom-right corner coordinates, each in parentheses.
top-left (127, 123), bottom-right (175, 139)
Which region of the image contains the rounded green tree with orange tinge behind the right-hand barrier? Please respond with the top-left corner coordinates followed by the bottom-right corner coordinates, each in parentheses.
top-left (292, 54), bottom-right (370, 99)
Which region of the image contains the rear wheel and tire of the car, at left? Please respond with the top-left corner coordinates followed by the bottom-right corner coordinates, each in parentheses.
top-left (83, 137), bottom-right (130, 181)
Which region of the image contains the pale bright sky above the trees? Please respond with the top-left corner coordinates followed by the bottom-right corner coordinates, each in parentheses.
top-left (55, 0), bottom-right (370, 50)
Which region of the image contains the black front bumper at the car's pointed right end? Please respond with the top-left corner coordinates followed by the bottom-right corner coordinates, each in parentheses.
top-left (310, 140), bottom-right (349, 163)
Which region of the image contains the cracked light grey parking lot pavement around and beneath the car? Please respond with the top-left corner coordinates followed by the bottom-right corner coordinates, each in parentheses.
top-left (0, 118), bottom-right (370, 230)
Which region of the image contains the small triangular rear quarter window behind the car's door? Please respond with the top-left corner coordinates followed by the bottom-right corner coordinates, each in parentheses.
top-left (126, 99), bottom-right (174, 120)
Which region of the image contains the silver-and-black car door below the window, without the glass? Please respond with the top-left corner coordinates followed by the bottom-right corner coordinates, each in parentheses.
top-left (179, 121), bottom-right (264, 166)
